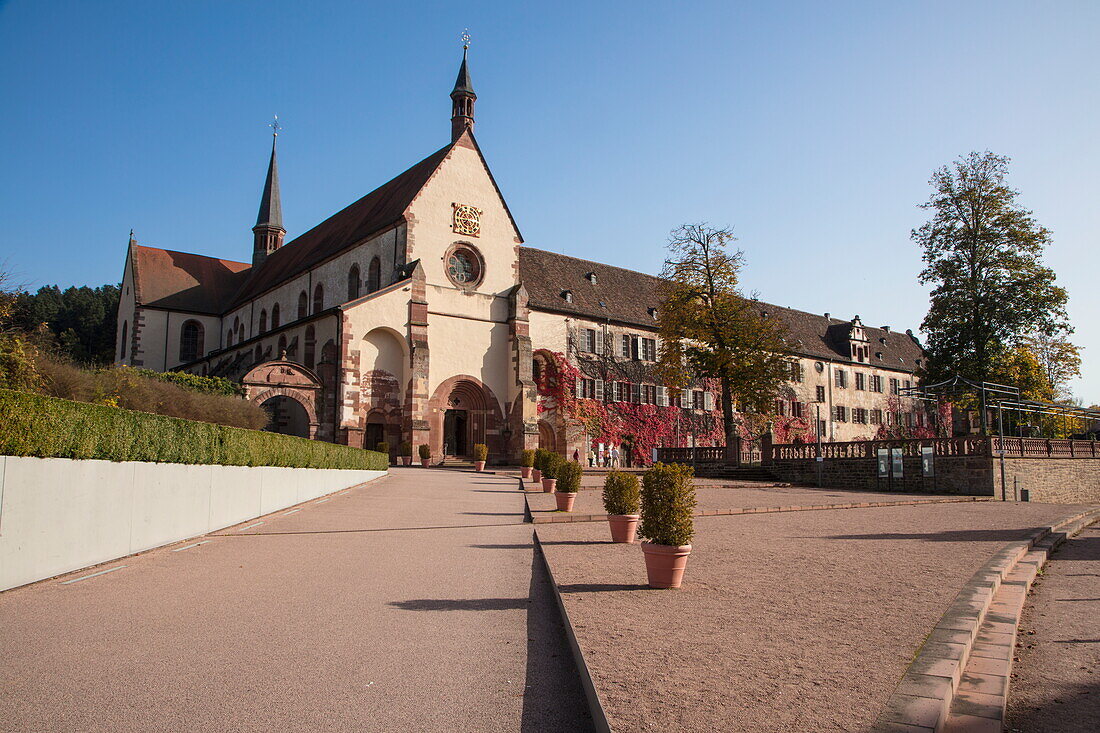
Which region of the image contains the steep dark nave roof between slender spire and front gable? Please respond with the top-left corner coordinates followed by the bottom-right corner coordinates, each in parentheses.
top-left (228, 138), bottom-right (462, 309)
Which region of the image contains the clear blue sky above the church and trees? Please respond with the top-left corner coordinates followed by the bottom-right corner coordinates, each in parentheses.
top-left (0, 0), bottom-right (1100, 403)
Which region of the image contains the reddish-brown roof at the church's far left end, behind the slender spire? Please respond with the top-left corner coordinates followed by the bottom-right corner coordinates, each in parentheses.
top-left (131, 244), bottom-right (252, 315)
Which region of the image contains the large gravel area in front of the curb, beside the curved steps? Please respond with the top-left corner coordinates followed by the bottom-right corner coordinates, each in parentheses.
top-left (538, 503), bottom-right (1075, 733)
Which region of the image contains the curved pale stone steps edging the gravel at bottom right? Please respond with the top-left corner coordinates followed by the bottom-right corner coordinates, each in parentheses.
top-left (871, 508), bottom-right (1100, 733)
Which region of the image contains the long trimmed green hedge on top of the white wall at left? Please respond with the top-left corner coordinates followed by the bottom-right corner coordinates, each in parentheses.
top-left (0, 390), bottom-right (389, 471)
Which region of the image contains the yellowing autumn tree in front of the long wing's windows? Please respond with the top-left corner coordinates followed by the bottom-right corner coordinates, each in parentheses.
top-left (657, 223), bottom-right (791, 446)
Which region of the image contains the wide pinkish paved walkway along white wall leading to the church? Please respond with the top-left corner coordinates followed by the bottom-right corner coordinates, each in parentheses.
top-left (0, 469), bottom-right (591, 731)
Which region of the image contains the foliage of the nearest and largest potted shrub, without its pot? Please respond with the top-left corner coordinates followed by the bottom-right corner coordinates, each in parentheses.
top-left (638, 463), bottom-right (695, 547)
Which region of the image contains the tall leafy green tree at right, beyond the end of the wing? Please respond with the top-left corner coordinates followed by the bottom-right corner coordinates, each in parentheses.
top-left (912, 152), bottom-right (1073, 382)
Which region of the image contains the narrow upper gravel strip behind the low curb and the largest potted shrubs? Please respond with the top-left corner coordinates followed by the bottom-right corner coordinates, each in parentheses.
top-left (527, 486), bottom-right (963, 515)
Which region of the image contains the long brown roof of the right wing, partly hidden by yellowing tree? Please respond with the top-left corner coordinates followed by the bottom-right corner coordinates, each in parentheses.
top-left (519, 247), bottom-right (923, 372)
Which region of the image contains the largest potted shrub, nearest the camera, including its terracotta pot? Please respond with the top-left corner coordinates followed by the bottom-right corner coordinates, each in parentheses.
top-left (641, 463), bottom-right (695, 588)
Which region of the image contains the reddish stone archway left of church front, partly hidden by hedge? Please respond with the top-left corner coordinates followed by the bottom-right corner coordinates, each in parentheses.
top-left (241, 360), bottom-right (321, 438)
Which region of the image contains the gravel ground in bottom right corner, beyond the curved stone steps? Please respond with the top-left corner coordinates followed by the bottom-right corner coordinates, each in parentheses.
top-left (1005, 525), bottom-right (1100, 733)
